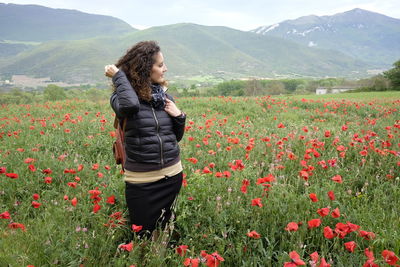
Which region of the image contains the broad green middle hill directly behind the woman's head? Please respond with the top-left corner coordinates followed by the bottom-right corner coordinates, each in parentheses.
top-left (0, 24), bottom-right (368, 82)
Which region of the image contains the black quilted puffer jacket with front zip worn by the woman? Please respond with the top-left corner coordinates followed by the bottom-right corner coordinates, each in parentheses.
top-left (110, 71), bottom-right (185, 172)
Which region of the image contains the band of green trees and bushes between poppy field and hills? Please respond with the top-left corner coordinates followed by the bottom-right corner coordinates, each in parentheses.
top-left (0, 60), bottom-right (400, 104)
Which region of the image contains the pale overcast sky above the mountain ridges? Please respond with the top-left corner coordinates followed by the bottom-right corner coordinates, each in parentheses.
top-left (5, 0), bottom-right (400, 31)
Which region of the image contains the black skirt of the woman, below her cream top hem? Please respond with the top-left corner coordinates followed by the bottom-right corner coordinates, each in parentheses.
top-left (125, 172), bottom-right (183, 236)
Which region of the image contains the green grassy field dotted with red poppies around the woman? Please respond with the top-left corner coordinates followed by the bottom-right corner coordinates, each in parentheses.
top-left (0, 92), bottom-right (400, 267)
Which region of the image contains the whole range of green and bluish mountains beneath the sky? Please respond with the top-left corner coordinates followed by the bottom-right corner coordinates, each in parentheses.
top-left (0, 4), bottom-right (400, 83)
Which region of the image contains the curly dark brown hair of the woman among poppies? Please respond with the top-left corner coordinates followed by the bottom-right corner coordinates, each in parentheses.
top-left (115, 41), bottom-right (161, 101)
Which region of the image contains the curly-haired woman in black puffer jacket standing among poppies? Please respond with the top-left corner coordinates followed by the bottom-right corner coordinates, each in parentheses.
top-left (105, 41), bottom-right (186, 240)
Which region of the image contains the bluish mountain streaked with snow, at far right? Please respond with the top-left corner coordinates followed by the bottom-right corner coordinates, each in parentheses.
top-left (252, 8), bottom-right (400, 65)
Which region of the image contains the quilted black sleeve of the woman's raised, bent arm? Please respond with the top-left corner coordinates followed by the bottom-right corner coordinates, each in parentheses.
top-left (110, 70), bottom-right (140, 118)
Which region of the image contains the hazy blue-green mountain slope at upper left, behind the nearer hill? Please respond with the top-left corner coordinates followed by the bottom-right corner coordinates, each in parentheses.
top-left (0, 3), bottom-right (136, 42)
